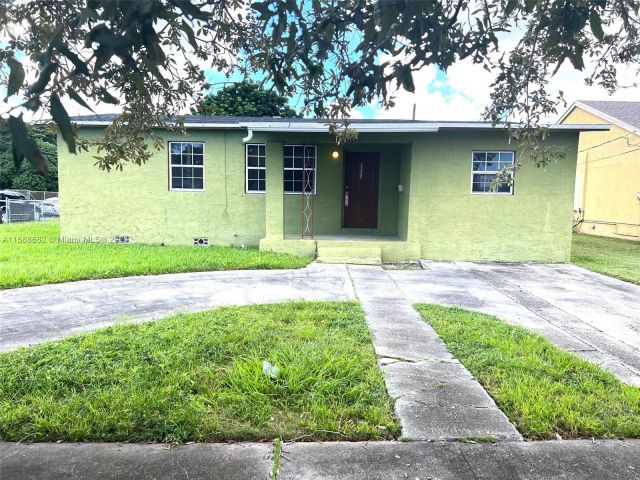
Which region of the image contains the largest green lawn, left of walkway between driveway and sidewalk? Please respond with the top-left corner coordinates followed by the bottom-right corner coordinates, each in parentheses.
top-left (0, 302), bottom-right (399, 442)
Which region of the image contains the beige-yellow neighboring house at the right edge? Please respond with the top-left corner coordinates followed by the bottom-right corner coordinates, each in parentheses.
top-left (558, 100), bottom-right (640, 240)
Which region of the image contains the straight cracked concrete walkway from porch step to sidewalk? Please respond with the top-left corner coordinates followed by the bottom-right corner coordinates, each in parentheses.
top-left (349, 266), bottom-right (522, 440)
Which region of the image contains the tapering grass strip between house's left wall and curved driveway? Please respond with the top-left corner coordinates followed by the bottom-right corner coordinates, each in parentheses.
top-left (0, 221), bottom-right (311, 289)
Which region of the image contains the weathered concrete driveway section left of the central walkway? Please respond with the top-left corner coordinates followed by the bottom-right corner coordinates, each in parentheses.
top-left (0, 263), bottom-right (355, 350)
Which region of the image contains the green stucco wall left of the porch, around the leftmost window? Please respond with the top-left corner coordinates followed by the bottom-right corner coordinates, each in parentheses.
top-left (58, 129), bottom-right (265, 245)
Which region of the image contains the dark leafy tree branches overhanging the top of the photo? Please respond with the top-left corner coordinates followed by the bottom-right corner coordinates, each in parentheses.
top-left (0, 0), bottom-right (640, 169)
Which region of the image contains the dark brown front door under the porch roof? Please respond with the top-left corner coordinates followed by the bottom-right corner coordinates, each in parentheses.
top-left (343, 152), bottom-right (380, 228)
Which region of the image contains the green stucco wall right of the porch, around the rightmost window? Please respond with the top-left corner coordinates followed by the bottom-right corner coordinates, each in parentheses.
top-left (408, 132), bottom-right (578, 262)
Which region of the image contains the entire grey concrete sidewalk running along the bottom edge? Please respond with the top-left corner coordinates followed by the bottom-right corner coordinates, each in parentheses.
top-left (0, 440), bottom-right (640, 480)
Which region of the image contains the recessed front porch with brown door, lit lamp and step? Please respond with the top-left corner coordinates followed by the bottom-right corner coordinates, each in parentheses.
top-left (260, 139), bottom-right (420, 264)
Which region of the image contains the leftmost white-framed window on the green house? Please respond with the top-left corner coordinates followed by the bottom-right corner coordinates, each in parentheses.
top-left (169, 142), bottom-right (204, 192)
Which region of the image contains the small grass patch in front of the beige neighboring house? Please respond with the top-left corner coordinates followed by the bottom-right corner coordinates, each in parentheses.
top-left (571, 234), bottom-right (640, 285)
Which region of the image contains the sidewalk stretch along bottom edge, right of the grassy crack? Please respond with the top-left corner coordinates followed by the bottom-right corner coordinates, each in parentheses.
top-left (278, 440), bottom-right (640, 480)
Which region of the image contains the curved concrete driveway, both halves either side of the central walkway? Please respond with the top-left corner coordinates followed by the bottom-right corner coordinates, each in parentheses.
top-left (0, 262), bottom-right (640, 385)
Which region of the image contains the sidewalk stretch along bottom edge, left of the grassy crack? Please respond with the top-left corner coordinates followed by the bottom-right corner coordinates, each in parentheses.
top-left (0, 443), bottom-right (273, 480)
